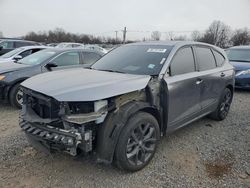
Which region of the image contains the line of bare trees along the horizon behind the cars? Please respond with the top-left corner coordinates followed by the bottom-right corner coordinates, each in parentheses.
top-left (0, 21), bottom-right (250, 48)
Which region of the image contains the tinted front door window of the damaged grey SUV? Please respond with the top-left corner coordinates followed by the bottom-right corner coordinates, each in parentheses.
top-left (170, 47), bottom-right (195, 76)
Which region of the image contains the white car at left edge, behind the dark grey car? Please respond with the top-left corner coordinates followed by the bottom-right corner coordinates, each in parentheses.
top-left (0, 46), bottom-right (48, 63)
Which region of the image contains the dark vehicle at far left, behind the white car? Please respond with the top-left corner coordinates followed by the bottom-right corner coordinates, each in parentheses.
top-left (0, 39), bottom-right (40, 55)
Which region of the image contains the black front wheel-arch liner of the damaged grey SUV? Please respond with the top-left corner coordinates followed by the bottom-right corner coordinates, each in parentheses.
top-left (96, 101), bottom-right (158, 164)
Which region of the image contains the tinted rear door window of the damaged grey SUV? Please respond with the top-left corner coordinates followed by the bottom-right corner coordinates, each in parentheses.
top-left (195, 47), bottom-right (216, 71)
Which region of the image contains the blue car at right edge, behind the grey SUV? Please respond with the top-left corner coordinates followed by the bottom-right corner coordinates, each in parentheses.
top-left (226, 46), bottom-right (250, 89)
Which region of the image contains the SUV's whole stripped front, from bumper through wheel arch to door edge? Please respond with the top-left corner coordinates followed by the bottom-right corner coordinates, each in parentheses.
top-left (20, 77), bottom-right (166, 163)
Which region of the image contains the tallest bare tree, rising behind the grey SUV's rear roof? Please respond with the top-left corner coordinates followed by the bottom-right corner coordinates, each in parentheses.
top-left (201, 21), bottom-right (230, 48)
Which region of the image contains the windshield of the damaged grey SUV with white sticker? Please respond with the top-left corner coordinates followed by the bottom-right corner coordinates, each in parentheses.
top-left (91, 45), bottom-right (172, 75)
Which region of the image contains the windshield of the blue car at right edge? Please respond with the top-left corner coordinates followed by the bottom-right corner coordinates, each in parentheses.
top-left (226, 49), bottom-right (250, 62)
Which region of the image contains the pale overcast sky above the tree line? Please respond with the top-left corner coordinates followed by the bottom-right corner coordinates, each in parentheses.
top-left (0, 0), bottom-right (250, 40)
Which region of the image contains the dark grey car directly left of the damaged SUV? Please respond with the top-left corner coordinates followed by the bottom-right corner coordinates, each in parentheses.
top-left (0, 48), bottom-right (103, 108)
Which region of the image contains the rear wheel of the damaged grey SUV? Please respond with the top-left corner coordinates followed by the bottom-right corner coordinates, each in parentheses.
top-left (209, 88), bottom-right (233, 121)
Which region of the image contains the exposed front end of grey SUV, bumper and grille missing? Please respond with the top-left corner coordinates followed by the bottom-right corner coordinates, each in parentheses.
top-left (20, 88), bottom-right (108, 156)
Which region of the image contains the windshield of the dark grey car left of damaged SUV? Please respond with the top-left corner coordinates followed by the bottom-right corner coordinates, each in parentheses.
top-left (18, 50), bottom-right (56, 65)
